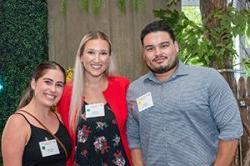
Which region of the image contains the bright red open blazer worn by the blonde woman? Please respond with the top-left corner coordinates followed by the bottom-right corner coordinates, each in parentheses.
top-left (57, 76), bottom-right (131, 166)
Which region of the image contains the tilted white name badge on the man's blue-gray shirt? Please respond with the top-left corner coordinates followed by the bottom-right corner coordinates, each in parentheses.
top-left (136, 92), bottom-right (154, 112)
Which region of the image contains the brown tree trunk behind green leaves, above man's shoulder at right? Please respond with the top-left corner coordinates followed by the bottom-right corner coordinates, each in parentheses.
top-left (200, 0), bottom-right (235, 91)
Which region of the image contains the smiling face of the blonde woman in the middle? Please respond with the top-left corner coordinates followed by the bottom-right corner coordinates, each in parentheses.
top-left (81, 39), bottom-right (111, 77)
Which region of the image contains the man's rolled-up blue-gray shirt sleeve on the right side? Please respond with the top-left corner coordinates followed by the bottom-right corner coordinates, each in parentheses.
top-left (209, 71), bottom-right (243, 140)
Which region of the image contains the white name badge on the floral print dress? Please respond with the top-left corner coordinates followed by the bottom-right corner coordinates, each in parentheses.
top-left (85, 103), bottom-right (105, 118)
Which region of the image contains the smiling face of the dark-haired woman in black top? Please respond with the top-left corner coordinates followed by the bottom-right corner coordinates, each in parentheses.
top-left (31, 69), bottom-right (64, 107)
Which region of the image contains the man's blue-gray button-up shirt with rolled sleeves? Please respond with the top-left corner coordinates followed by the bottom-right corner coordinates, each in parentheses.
top-left (127, 62), bottom-right (243, 166)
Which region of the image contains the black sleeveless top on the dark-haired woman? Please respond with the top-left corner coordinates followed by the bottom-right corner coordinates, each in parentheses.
top-left (18, 113), bottom-right (72, 166)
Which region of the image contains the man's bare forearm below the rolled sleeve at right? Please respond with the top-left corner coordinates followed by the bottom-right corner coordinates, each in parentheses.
top-left (214, 140), bottom-right (238, 166)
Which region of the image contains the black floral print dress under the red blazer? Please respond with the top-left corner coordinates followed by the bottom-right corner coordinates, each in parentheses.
top-left (75, 103), bottom-right (129, 166)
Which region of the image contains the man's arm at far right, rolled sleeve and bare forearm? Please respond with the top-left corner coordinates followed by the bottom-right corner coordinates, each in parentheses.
top-left (208, 69), bottom-right (243, 166)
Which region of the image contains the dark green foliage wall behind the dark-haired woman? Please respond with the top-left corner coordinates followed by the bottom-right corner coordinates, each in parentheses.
top-left (0, 0), bottom-right (48, 144)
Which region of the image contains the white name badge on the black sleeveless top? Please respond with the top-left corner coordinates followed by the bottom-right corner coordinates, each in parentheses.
top-left (39, 139), bottom-right (60, 157)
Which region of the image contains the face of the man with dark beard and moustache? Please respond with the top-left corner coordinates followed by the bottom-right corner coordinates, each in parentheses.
top-left (143, 31), bottom-right (179, 77)
